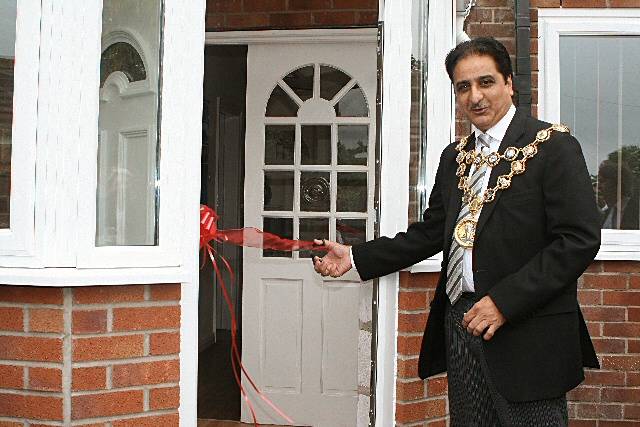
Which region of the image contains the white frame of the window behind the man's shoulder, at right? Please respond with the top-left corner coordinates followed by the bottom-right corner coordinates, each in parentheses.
top-left (538, 9), bottom-right (640, 261)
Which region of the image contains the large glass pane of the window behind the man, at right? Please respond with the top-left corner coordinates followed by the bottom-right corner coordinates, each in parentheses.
top-left (560, 36), bottom-right (640, 230)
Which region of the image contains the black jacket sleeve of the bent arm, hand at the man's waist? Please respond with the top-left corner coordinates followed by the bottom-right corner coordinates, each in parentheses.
top-left (489, 134), bottom-right (600, 321)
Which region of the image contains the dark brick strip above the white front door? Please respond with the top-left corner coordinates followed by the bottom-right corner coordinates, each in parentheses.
top-left (206, 0), bottom-right (378, 31)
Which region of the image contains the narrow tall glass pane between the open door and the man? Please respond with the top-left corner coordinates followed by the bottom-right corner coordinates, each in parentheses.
top-left (409, 0), bottom-right (435, 223)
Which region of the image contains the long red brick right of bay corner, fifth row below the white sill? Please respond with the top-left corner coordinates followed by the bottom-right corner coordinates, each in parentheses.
top-left (71, 390), bottom-right (144, 420)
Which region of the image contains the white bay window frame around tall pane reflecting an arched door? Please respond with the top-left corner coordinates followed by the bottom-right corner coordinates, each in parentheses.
top-left (0, 0), bottom-right (205, 280)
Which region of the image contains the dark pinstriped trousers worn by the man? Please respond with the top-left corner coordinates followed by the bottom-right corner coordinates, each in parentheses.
top-left (445, 293), bottom-right (569, 427)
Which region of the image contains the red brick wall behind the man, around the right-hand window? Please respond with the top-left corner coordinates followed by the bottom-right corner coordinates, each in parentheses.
top-left (396, 0), bottom-right (640, 427)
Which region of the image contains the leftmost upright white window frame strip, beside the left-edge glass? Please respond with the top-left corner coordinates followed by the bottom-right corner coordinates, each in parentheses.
top-left (0, 0), bottom-right (40, 265)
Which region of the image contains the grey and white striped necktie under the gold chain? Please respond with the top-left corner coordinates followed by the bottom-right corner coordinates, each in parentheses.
top-left (446, 134), bottom-right (489, 305)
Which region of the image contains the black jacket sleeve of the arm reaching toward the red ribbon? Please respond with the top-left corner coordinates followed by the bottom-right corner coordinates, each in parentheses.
top-left (352, 146), bottom-right (453, 280)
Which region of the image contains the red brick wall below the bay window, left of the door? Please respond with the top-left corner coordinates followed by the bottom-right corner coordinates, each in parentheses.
top-left (0, 284), bottom-right (180, 427)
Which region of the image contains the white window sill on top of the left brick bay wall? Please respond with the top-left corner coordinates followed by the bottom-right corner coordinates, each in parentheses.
top-left (0, 267), bottom-right (191, 287)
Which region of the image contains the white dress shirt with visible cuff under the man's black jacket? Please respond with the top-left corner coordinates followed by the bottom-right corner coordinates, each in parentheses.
top-left (349, 105), bottom-right (516, 286)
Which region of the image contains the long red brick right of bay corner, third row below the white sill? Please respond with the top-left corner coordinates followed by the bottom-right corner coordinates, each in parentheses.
top-left (73, 335), bottom-right (144, 361)
